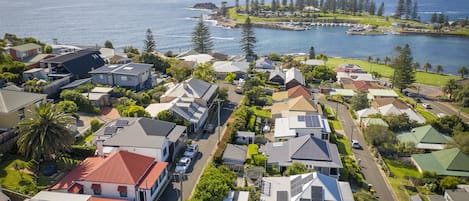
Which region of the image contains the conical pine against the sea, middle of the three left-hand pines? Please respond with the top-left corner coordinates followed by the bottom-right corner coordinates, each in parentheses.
top-left (192, 16), bottom-right (213, 54)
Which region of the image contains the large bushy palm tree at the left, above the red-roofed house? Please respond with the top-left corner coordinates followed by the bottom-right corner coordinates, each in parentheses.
top-left (17, 103), bottom-right (74, 161)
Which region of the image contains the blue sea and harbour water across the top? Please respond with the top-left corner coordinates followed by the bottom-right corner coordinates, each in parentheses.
top-left (0, 0), bottom-right (469, 73)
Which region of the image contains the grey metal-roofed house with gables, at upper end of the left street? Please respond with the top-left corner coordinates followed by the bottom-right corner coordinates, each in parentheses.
top-left (160, 78), bottom-right (218, 108)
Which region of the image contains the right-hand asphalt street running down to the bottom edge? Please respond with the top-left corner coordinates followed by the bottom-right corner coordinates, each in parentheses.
top-left (321, 101), bottom-right (394, 201)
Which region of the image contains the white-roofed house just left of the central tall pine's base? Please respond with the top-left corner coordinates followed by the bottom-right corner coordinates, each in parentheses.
top-left (213, 61), bottom-right (249, 80)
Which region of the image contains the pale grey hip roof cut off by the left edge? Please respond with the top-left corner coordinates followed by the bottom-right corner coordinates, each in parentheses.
top-left (0, 89), bottom-right (47, 113)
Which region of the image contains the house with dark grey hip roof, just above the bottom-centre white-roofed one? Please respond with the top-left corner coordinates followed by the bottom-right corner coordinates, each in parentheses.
top-left (259, 135), bottom-right (342, 178)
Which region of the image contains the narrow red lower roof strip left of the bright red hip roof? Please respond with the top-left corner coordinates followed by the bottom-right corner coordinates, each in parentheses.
top-left (50, 157), bottom-right (104, 190)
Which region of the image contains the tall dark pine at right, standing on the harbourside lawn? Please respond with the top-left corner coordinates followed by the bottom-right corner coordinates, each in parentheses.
top-left (391, 44), bottom-right (415, 92)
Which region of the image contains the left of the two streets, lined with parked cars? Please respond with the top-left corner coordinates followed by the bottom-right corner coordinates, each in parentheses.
top-left (159, 83), bottom-right (242, 201)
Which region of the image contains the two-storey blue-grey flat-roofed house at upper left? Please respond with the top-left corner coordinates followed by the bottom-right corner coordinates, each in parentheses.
top-left (89, 63), bottom-right (152, 91)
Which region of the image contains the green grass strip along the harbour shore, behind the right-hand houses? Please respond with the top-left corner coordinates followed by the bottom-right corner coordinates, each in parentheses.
top-left (326, 58), bottom-right (461, 86)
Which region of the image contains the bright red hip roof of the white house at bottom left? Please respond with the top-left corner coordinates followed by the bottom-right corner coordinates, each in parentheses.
top-left (83, 151), bottom-right (155, 185)
